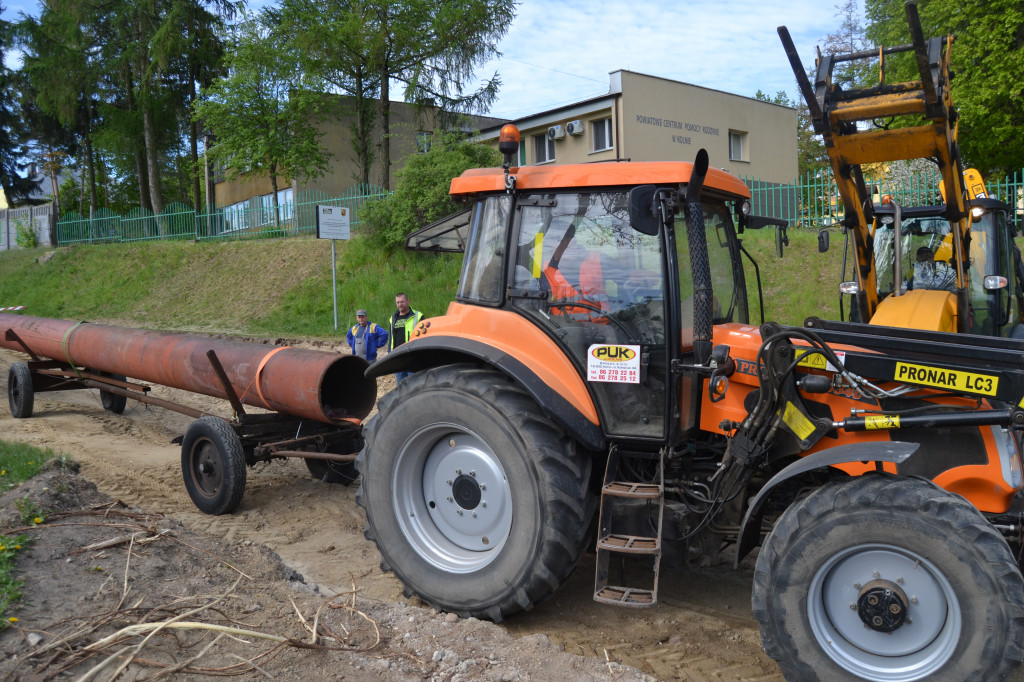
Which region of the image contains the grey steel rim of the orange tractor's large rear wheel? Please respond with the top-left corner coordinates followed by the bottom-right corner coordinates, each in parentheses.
top-left (391, 424), bottom-right (512, 573)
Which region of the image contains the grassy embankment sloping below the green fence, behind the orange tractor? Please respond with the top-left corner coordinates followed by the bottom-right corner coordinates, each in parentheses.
top-left (0, 229), bottom-right (843, 341)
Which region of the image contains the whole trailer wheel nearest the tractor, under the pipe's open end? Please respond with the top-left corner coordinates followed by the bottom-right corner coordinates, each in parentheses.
top-left (181, 417), bottom-right (246, 515)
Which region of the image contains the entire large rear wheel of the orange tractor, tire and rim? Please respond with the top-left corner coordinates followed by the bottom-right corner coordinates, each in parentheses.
top-left (356, 365), bottom-right (595, 621)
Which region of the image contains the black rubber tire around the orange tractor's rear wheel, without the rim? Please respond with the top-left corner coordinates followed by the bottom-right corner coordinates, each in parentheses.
top-left (355, 365), bottom-right (596, 622)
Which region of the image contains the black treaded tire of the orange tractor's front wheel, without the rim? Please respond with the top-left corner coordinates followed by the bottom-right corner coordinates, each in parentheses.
top-left (752, 474), bottom-right (1024, 681)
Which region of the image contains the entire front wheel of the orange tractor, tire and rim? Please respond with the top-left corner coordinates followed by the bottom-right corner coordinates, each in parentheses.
top-left (753, 475), bottom-right (1024, 682)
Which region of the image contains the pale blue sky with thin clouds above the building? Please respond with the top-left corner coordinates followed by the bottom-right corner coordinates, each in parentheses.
top-left (0, 0), bottom-right (839, 119)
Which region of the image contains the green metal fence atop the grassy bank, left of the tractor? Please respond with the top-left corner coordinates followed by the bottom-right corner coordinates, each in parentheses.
top-left (56, 184), bottom-right (390, 246)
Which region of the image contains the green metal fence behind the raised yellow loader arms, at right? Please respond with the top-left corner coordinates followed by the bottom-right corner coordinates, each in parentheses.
top-left (743, 169), bottom-right (1024, 227)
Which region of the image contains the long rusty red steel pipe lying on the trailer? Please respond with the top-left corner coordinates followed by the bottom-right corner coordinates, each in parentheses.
top-left (0, 313), bottom-right (377, 424)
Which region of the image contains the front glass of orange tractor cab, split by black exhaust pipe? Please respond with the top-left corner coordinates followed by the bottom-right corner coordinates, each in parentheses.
top-left (676, 202), bottom-right (749, 348)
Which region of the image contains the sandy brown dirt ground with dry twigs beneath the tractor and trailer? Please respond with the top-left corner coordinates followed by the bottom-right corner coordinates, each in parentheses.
top-left (0, 350), bottom-right (782, 681)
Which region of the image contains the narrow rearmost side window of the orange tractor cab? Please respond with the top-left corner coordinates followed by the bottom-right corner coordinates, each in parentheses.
top-left (458, 195), bottom-right (512, 303)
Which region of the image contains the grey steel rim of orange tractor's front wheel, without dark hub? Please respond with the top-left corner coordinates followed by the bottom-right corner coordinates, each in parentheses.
top-left (807, 544), bottom-right (963, 682)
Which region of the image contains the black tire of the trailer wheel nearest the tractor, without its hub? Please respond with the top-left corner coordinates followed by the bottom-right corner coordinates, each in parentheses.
top-left (181, 417), bottom-right (246, 516)
